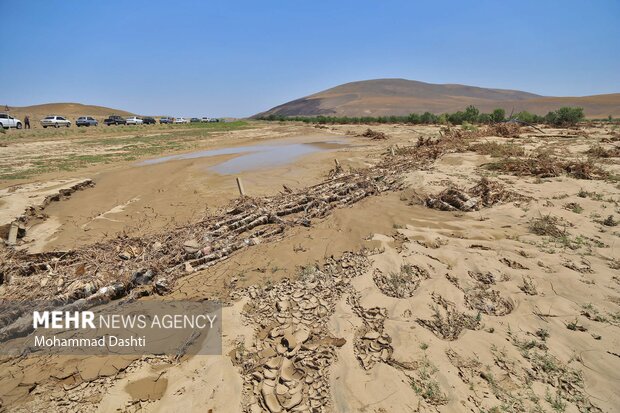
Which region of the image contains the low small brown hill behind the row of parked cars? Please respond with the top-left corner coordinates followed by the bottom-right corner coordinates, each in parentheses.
top-left (6, 103), bottom-right (133, 120)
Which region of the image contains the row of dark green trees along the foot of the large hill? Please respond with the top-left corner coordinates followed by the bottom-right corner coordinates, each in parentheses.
top-left (258, 105), bottom-right (584, 126)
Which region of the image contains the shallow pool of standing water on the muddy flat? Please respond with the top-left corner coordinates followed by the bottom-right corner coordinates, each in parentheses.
top-left (138, 140), bottom-right (346, 175)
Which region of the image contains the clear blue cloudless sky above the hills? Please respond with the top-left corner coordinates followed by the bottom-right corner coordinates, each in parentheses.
top-left (0, 0), bottom-right (620, 116)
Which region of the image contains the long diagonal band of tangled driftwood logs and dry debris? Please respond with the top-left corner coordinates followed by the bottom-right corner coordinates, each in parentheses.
top-left (0, 130), bottom-right (466, 334)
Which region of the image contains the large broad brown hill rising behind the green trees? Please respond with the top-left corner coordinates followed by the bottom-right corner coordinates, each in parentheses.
top-left (256, 79), bottom-right (620, 117)
